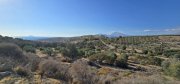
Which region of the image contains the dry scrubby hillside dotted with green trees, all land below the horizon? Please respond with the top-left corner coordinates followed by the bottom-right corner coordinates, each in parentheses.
top-left (0, 35), bottom-right (180, 84)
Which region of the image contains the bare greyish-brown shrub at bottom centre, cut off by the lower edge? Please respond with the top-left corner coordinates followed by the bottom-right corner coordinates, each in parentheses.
top-left (71, 59), bottom-right (99, 84)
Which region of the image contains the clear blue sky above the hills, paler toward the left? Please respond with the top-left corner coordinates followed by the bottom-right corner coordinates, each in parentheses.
top-left (0, 0), bottom-right (180, 37)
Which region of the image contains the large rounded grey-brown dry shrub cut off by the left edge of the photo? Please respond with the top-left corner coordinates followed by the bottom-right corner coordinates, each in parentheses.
top-left (0, 43), bottom-right (27, 71)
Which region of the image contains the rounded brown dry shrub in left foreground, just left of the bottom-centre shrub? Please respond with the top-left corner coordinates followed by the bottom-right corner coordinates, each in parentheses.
top-left (39, 59), bottom-right (71, 82)
